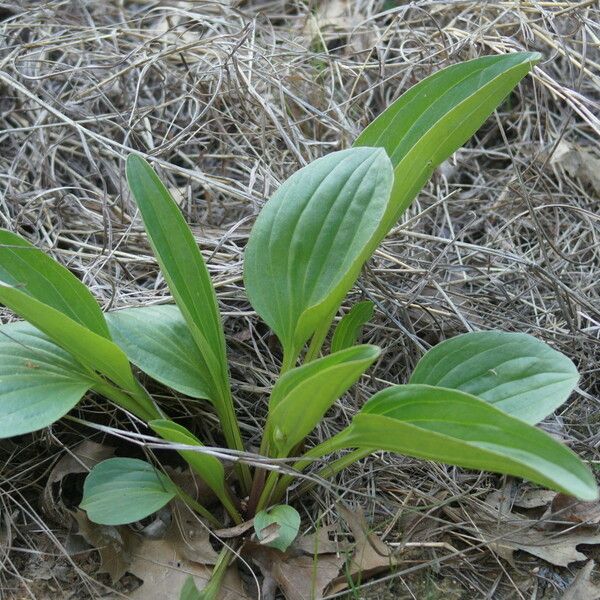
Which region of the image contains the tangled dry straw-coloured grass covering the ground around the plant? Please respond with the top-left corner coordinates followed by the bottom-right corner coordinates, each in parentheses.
top-left (0, 0), bottom-right (600, 599)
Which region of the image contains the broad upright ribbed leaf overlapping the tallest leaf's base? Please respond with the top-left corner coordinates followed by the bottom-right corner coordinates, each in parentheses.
top-left (244, 148), bottom-right (393, 357)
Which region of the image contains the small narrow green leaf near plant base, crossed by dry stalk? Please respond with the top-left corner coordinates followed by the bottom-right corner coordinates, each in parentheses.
top-left (148, 419), bottom-right (241, 522)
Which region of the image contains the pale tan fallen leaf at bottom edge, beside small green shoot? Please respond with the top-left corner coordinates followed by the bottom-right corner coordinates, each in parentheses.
top-left (129, 540), bottom-right (251, 600)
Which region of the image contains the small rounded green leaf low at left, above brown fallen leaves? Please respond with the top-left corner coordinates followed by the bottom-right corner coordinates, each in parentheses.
top-left (80, 458), bottom-right (177, 525)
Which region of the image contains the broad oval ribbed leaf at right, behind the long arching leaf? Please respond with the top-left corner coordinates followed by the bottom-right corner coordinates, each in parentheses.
top-left (410, 331), bottom-right (579, 424)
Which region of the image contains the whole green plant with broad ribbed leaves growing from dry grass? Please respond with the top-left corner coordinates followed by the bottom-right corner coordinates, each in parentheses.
top-left (0, 53), bottom-right (597, 597)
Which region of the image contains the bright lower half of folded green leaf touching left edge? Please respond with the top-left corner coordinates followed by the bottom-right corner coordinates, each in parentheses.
top-left (0, 283), bottom-right (159, 418)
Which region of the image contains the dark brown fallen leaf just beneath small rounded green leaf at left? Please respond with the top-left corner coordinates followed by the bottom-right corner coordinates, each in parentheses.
top-left (71, 509), bottom-right (141, 583)
